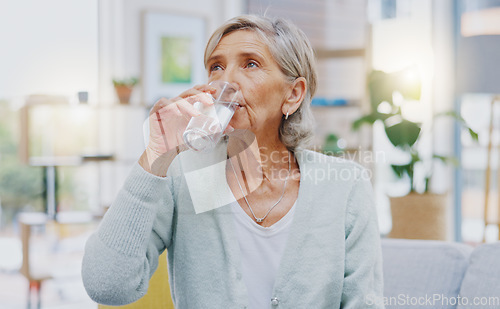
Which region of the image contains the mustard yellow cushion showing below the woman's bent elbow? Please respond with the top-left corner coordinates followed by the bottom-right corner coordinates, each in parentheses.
top-left (98, 250), bottom-right (174, 309)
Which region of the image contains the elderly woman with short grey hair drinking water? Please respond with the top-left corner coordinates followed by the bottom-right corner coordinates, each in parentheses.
top-left (83, 16), bottom-right (383, 309)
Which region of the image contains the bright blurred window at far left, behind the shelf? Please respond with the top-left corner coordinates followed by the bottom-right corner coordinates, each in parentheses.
top-left (0, 0), bottom-right (98, 227)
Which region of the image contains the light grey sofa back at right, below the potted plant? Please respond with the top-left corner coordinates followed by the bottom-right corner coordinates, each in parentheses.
top-left (380, 239), bottom-right (500, 309)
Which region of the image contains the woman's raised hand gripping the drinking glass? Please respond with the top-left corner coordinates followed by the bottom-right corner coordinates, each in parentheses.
top-left (139, 85), bottom-right (216, 176)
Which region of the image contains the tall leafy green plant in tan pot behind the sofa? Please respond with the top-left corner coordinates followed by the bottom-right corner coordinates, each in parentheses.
top-left (353, 69), bottom-right (478, 240)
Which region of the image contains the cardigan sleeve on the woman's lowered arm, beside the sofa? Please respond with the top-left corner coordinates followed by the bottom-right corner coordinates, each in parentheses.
top-left (341, 173), bottom-right (384, 309)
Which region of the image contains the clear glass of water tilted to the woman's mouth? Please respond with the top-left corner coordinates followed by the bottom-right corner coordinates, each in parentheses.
top-left (183, 81), bottom-right (241, 152)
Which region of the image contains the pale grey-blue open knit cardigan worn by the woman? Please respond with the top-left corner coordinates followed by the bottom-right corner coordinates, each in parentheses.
top-left (82, 143), bottom-right (383, 309)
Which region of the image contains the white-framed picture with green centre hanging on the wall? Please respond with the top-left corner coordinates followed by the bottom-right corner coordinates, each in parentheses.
top-left (142, 11), bottom-right (206, 106)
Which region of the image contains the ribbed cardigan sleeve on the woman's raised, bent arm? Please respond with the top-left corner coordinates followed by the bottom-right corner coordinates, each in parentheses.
top-left (82, 164), bottom-right (174, 305)
